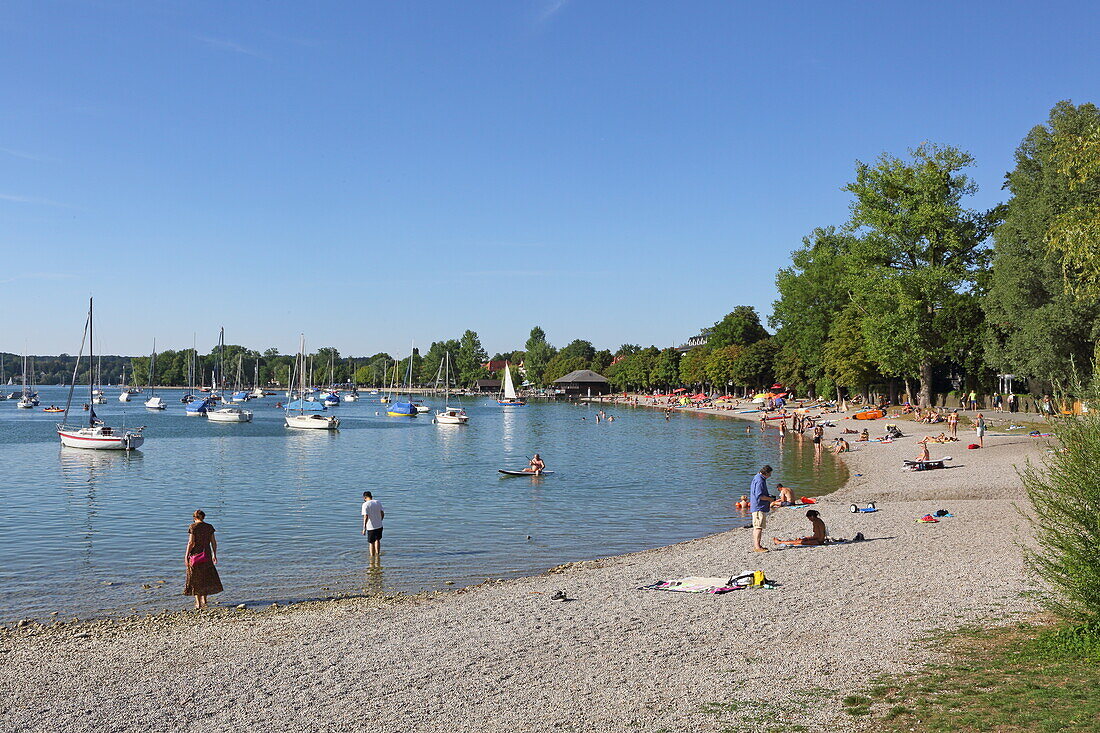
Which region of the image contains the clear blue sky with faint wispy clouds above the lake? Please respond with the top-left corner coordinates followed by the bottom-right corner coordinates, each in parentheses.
top-left (0, 0), bottom-right (1100, 354)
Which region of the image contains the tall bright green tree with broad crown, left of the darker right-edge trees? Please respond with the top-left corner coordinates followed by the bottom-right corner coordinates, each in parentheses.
top-left (846, 144), bottom-right (1000, 405)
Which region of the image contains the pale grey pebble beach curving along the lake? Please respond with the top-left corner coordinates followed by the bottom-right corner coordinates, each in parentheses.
top-left (0, 400), bottom-right (1047, 731)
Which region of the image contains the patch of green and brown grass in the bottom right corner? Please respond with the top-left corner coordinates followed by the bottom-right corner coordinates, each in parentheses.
top-left (842, 623), bottom-right (1100, 732)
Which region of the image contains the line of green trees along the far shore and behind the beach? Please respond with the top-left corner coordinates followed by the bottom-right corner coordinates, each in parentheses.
top-left (4, 101), bottom-right (1100, 404)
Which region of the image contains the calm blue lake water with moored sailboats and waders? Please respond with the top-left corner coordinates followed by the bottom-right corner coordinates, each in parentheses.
top-left (0, 387), bottom-right (847, 623)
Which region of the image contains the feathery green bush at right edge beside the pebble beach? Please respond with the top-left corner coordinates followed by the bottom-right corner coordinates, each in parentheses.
top-left (1021, 412), bottom-right (1100, 627)
